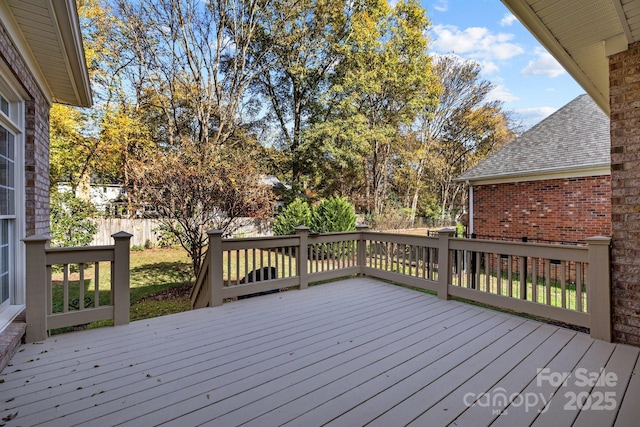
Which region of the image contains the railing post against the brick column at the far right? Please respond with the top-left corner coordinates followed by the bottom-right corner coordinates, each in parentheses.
top-left (585, 236), bottom-right (611, 342)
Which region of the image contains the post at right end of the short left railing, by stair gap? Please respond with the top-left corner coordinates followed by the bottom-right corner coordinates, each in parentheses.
top-left (111, 231), bottom-right (133, 325)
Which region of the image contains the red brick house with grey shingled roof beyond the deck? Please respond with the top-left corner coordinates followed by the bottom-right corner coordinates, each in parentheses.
top-left (457, 95), bottom-right (611, 244)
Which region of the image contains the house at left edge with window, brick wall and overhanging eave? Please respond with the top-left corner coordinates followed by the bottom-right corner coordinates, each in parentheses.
top-left (0, 0), bottom-right (91, 342)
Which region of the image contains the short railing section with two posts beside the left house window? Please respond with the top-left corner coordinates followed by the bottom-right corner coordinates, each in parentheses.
top-left (24, 231), bottom-right (132, 342)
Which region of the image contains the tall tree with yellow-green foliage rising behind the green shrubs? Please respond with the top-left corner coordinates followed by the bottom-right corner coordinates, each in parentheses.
top-left (308, 0), bottom-right (437, 214)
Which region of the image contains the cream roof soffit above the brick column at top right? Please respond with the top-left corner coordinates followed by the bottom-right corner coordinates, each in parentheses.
top-left (502, 0), bottom-right (640, 114)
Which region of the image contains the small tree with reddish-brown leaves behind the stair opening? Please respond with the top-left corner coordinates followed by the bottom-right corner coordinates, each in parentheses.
top-left (133, 147), bottom-right (273, 276)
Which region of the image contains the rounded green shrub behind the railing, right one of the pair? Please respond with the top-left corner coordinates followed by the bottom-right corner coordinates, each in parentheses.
top-left (310, 197), bottom-right (357, 233)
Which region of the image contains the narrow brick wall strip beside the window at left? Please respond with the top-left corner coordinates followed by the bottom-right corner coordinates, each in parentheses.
top-left (0, 20), bottom-right (51, 236)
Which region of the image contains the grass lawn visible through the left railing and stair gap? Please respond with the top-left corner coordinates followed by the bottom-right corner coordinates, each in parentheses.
top-left (52, 248), bottom-right (194, 333)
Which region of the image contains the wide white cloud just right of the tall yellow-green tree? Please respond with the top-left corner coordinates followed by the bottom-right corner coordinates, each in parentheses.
top-left (431, 25), bottom-right (524, 63)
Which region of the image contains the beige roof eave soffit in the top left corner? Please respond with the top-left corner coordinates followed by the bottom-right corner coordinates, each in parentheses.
top-left (5, 0), bottom-right (91, 107)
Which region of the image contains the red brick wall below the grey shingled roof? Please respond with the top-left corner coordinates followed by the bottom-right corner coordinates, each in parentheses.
top-left (473, 176), bottom-right (611, 242)
